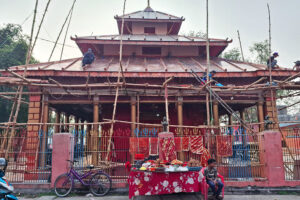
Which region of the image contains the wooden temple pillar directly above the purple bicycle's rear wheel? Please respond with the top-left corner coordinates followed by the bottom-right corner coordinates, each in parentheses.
top-left (91, 96), bottom-right (99, 166)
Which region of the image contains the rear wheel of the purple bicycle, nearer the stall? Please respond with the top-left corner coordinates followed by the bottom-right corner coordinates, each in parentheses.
top-left (90, 172), bottom-right (112, 197)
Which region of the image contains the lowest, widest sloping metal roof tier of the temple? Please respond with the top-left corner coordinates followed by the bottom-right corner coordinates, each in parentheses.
top-left (10, 57), bottom-right (266, 73)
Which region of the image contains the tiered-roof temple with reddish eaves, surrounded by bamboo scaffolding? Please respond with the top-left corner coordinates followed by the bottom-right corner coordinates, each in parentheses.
top-left (2, 2), bottom-right (296, 184)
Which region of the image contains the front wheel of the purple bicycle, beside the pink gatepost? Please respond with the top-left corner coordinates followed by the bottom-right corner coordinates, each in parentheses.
top-left (54, 174), bottom-right (73, 197)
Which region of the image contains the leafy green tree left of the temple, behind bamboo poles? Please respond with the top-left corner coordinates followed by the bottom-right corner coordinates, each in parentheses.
top-left (0, 24), bottom-right (37, 122)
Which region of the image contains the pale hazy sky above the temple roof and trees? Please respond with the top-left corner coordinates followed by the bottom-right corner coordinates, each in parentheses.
top-left (0, 0), bottom-right (300, 67)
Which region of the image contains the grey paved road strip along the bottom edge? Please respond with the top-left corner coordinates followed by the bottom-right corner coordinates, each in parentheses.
top-left (20, 195), bottom-right (300, 200)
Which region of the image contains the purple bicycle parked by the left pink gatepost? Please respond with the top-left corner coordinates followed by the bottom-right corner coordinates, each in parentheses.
top-left (54, 160), bottom-right (112, 197)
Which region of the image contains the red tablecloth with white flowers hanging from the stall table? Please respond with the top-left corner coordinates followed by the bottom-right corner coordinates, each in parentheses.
top-left (128, 171), bottom-right (201, 199)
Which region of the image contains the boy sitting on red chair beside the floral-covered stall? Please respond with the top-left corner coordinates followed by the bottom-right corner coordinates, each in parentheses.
top-left (204, 159), bottom-right (224, 199)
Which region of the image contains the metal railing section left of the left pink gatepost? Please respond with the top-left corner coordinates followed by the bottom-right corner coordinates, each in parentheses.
top-left (0, 129), bottom-right (52, 183)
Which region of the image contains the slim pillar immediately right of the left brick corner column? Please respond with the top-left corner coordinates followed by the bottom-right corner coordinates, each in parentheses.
top-left (40, 95), bottom-right (49, 167)
